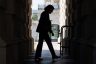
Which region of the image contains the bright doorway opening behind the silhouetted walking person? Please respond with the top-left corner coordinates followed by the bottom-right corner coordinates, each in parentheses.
top-left (31, 0), bottom-right (66, 55)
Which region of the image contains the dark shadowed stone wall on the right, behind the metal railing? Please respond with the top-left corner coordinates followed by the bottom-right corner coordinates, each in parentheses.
top-left (70, 0), bottom-right (96, 64)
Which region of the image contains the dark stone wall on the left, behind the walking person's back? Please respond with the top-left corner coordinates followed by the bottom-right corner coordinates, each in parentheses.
top-left (0, 0), bottom-right (32, 64)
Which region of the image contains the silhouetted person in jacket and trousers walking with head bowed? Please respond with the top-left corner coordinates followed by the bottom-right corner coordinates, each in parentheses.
top-left (35, 5), bottom-right (59, 61)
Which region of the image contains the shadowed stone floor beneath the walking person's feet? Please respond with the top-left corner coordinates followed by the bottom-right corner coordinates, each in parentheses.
top-left (24, 50), bottom-right (75, 64)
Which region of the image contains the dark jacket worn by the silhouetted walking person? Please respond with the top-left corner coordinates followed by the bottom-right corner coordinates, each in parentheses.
top-left (36, 11), bottom-right (52, 33)
